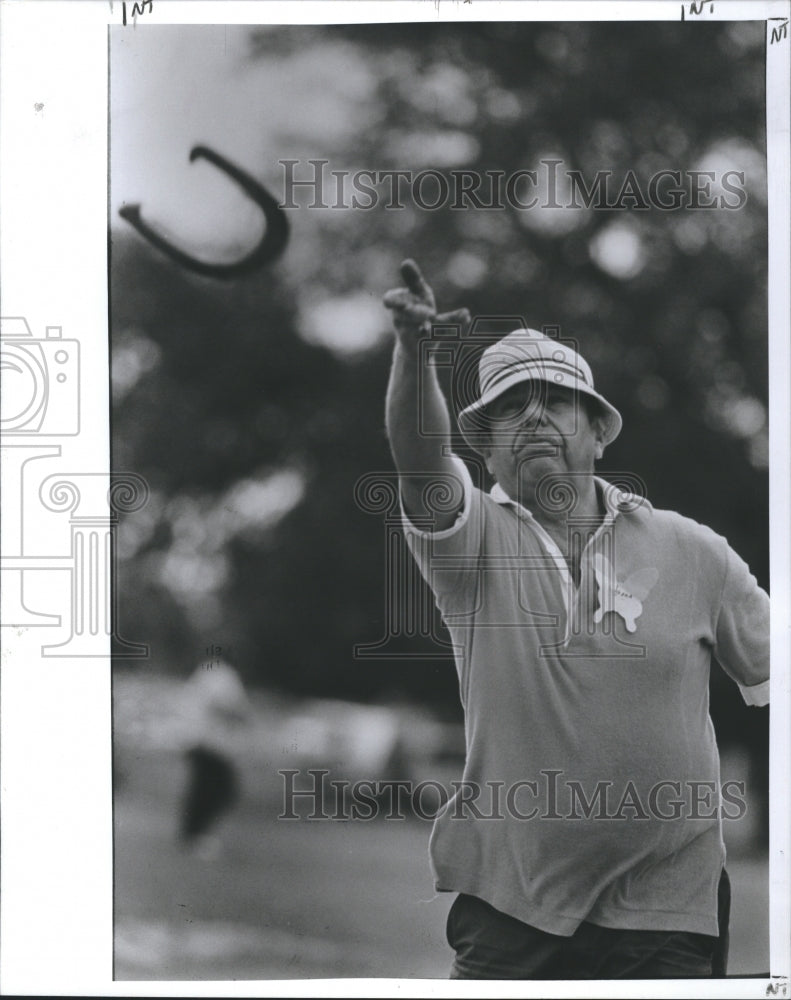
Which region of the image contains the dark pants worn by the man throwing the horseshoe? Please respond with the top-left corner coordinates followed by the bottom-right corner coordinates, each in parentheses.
top-left (447, 871), bottom-right (731, 979)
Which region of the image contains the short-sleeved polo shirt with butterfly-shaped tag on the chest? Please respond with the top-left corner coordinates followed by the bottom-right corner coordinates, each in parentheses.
top-left (404, 458), bottom-right (769, 936)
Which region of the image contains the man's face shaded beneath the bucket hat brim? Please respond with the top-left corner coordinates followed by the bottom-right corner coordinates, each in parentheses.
top-left (484, 382), bottom-right (604, 505)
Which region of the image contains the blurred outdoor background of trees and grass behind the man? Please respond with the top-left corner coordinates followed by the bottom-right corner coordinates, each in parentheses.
top-left (110, 22), bottom-right (769, 979)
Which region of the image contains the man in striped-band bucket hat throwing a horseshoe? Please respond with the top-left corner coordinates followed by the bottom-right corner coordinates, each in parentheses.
top-left (384, 261), bottom-right (769, 980)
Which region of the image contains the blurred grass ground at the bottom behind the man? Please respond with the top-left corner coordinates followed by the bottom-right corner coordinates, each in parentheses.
top-left (115, 745), bottom-right (768, 980)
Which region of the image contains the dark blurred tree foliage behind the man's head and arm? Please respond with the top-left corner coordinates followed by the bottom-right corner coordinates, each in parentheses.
top-left (111, 22), bottom-right (768, 768)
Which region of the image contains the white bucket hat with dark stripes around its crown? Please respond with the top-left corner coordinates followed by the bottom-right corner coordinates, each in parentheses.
top-left (459, 329), bottom-right (623, 452)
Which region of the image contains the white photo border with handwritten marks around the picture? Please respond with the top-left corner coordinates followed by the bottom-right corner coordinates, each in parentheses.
top-left (0, 0), bottom-right (791, 997)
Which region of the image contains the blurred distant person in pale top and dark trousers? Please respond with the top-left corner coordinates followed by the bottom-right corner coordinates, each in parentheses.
top-left (178, 660), bottom-right (251, 860)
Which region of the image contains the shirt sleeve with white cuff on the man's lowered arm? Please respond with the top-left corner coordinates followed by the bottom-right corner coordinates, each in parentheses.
top-left (714, 545), bottom-right (769, 705)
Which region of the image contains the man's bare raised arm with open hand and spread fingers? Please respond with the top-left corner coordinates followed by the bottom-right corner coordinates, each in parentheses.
top-left (383, 260), bottom-right (470, 531)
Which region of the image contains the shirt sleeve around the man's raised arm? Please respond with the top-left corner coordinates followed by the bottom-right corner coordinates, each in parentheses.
top-left (401, 455), bottom-right (484, 597)
